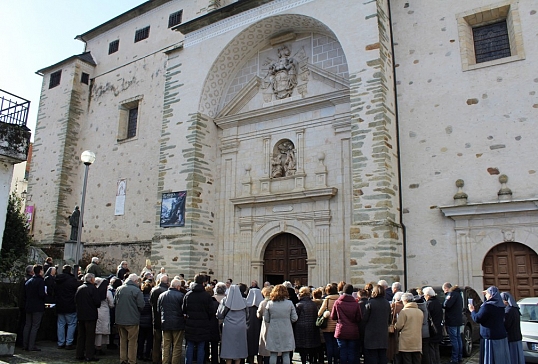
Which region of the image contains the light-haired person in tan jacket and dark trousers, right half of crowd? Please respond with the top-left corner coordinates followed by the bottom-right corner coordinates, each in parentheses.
top-left (395, 293), bottom-right (424, 364)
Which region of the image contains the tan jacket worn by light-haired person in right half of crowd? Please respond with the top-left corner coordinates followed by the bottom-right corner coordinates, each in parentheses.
top-left (396, 302), bottom-right (424, 352)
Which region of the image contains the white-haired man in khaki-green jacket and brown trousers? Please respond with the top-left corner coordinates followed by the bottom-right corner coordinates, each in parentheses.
top-left (114, 273), bottom-right (146, 364)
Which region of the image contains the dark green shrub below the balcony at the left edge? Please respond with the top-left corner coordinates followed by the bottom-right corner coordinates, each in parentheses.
top-left (0, 193), bottom-right (32, 280)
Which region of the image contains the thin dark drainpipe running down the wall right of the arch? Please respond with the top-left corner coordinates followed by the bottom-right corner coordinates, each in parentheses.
top-left (387, 0), bottom-right (409, 289)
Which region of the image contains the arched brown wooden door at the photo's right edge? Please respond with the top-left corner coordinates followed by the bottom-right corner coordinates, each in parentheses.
top-left (482, 243), bottom-right (538, 300)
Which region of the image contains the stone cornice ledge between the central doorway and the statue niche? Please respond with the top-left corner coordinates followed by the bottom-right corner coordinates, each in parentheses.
top-left (230, 187), bottom-right (338, 208)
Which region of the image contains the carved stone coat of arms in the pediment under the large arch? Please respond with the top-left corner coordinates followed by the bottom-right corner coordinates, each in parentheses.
top-left (265, 45), bottom-right (298, 100)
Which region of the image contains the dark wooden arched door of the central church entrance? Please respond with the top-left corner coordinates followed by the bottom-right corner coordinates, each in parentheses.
top-left (263, 233), bottom-right (308, 285)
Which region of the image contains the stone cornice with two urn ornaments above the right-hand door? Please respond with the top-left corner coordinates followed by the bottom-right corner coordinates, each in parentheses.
top-left (439, 198), bottom-right (538, 220)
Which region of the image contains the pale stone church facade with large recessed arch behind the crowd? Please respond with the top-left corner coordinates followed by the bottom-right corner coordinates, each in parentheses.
top-left (29, 0), bottom-right (538, 296)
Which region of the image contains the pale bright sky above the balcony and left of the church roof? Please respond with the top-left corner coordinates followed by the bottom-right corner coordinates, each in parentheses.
top-left (0, 0), bottom-right (146, 140)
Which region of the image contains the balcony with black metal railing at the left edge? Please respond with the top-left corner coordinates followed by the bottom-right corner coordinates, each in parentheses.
top-left (0, 90), bottom-right (31, 164)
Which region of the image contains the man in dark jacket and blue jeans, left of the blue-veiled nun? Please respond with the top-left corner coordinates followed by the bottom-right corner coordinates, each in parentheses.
top-left (443, 282), bottom-right (463, 363)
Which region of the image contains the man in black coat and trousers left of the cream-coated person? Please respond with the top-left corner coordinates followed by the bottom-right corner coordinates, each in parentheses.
top-left (75, 273), bottom-right (101, 361)
